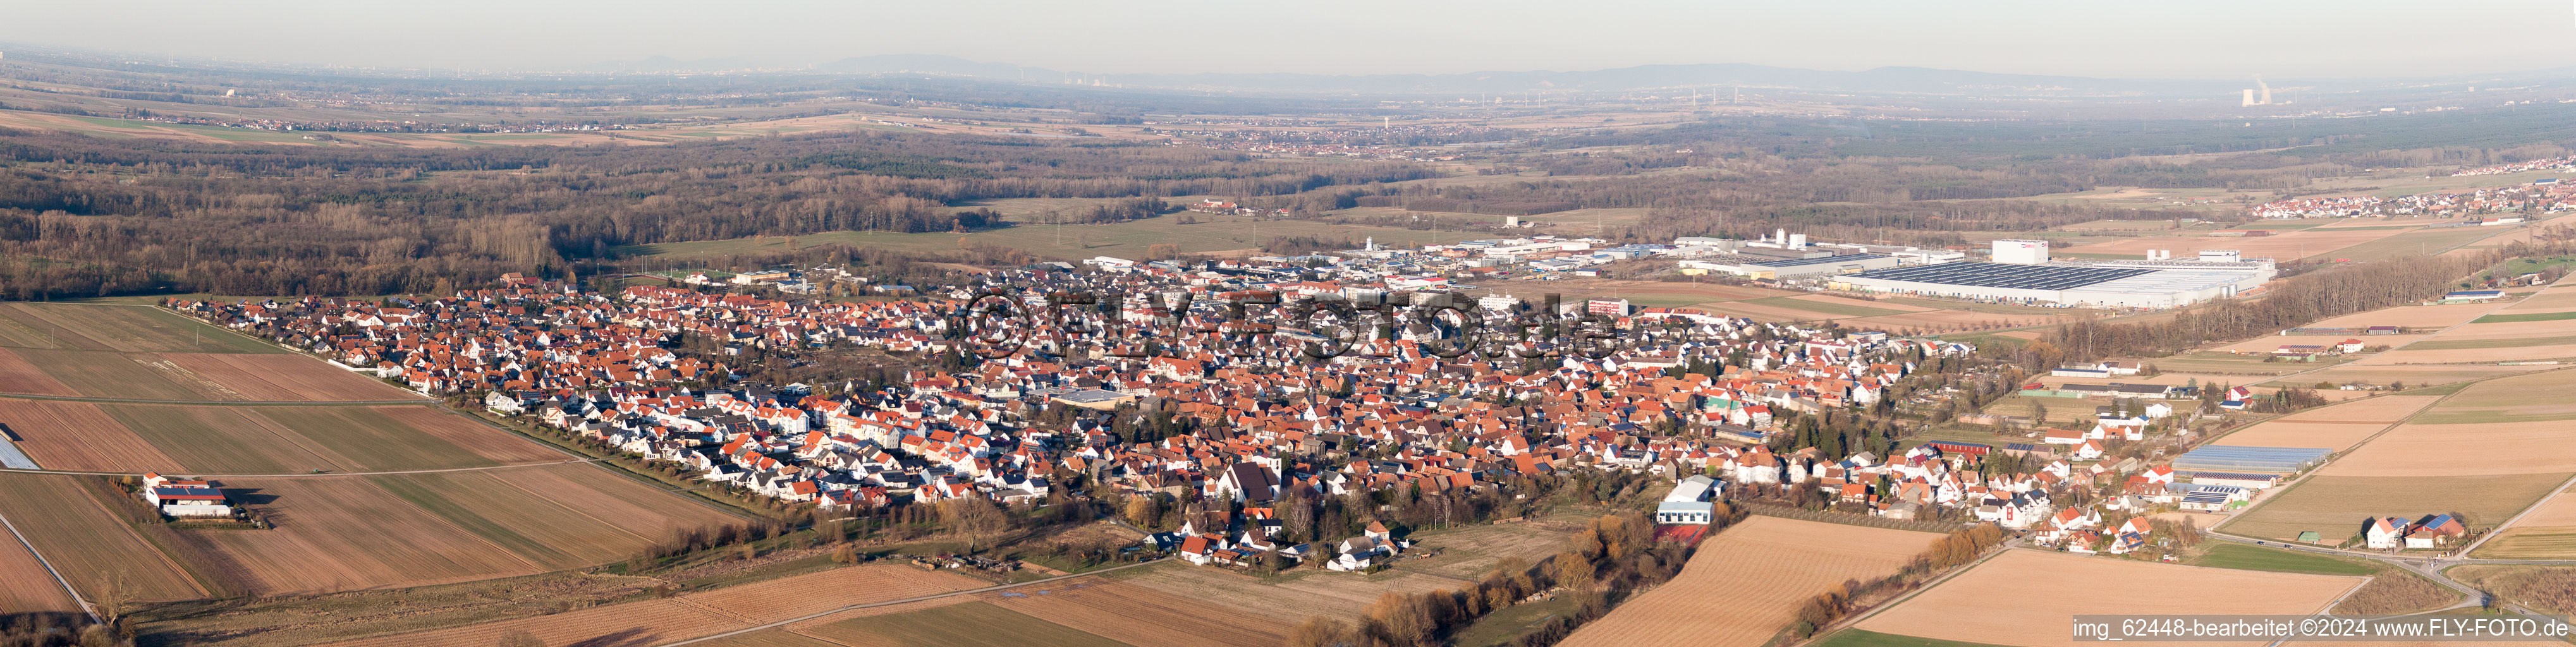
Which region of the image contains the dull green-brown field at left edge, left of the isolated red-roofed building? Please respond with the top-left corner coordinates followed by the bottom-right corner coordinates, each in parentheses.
top-left (0, 475), bottom-right (206, 601)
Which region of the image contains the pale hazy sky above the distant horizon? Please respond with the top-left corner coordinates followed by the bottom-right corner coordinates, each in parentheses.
top-left (0, 0), bottom-right (2576, 80)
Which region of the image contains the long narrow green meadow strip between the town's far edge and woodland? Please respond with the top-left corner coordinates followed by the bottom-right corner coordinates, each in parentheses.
top-left (618, 214), bottom-right (1491, 260)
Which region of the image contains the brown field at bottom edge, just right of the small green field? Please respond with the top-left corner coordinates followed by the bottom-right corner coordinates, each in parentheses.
top-left (982, 580), bottom-right (1291, 647)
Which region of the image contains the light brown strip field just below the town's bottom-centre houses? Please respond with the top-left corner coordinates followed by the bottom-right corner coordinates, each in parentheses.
top-left (1118, 564), bottom-right (1468, 621)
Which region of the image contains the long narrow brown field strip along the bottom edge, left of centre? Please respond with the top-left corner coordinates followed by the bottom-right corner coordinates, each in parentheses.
top-left (312, 564), bottom-right (987, 647)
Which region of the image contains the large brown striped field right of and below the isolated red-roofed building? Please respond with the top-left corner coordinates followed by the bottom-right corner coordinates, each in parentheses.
top-left (183, 464), bottom-right (731, 593)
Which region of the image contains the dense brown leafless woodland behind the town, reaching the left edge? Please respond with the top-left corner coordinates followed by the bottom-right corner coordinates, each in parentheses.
top-left (0, 131), bottom-right (1432, 299)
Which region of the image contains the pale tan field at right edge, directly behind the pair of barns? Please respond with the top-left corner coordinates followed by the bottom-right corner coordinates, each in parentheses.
top-left (2221, 475), bottom-right (2568, 544)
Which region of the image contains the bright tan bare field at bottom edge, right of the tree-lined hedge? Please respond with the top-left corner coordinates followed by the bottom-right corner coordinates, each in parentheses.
top-left (1561, 516), bottom-right (1939, 647)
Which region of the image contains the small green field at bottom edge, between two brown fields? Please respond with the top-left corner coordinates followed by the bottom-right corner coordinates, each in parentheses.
top-left (803, 603), bottom-right (1126, 647)
